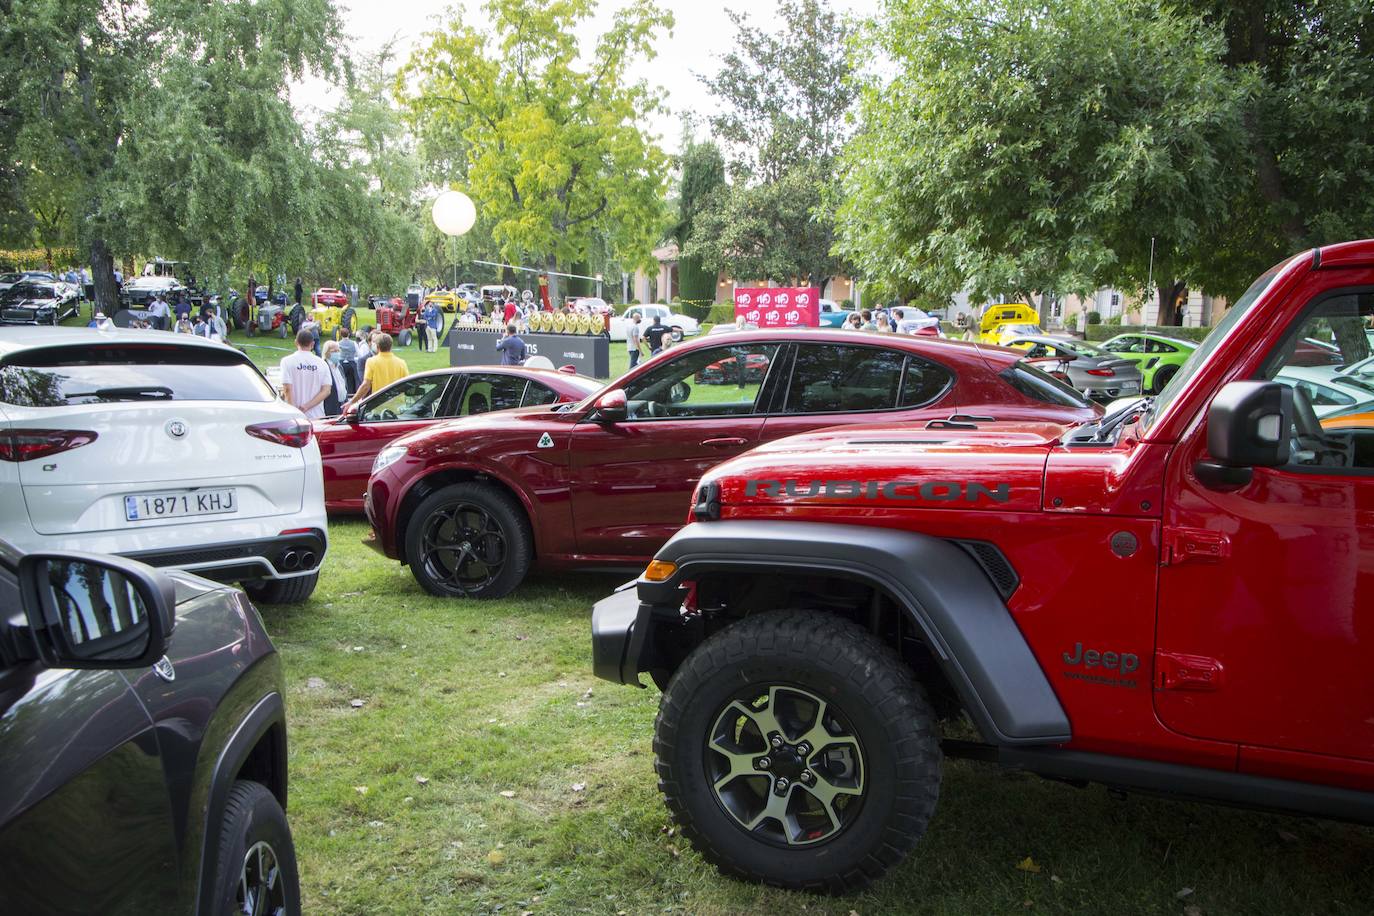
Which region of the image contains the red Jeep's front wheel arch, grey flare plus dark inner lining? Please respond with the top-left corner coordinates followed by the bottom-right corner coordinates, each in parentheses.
top-left (639, 520), bottom-right (1072, 746)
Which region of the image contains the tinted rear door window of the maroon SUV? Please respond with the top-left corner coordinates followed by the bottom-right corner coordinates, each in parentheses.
top-left (783, 343), bottom-right (905, 413)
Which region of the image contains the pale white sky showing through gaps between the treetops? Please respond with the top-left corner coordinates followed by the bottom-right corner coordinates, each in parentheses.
top-left (291, 0), bottom-right (879, 151)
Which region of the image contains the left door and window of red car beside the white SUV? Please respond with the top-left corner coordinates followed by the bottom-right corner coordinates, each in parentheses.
top-left (320, 375), bottom-right (462, 508)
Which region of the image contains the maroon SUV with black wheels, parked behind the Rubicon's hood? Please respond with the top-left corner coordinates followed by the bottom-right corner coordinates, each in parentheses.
top-left (367, 330), bottom-right (1101, 597)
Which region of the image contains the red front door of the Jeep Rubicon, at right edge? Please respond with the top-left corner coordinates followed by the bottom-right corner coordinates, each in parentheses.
top-left (1154, 281), bottom-right (1374, 773)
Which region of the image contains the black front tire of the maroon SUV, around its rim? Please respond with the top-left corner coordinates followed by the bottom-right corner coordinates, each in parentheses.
top-left (405, 481), bottom-right (534, 600)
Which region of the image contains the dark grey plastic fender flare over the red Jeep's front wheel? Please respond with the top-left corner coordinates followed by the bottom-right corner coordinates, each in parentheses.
top-left (638, 519), bottom-right (1072, 746)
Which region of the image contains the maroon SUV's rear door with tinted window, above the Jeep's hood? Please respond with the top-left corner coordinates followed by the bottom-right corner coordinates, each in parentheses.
top-left (763, 343), bottom-right (958, 442)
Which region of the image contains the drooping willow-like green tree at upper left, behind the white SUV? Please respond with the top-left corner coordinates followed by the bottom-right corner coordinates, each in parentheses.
top-left (4, 0), bottom-right (341, 309)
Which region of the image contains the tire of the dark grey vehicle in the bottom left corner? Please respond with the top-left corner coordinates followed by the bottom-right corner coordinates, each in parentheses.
top-left (213, 780), bottom-right (301, 916)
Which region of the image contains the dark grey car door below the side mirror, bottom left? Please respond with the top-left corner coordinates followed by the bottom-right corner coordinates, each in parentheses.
top-left (0, 570), bottom-right (184, 915)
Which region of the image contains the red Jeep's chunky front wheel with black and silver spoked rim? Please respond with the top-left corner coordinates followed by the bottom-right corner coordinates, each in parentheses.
top-left (654, 611), bottom-right (941, 893)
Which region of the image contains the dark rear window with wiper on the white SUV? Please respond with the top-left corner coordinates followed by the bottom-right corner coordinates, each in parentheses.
top-left (0, 345), bottom-right (276, 407)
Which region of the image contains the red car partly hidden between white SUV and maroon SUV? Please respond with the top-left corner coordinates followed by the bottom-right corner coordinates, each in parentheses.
top-left (315, 365), bottom-right (602, 512)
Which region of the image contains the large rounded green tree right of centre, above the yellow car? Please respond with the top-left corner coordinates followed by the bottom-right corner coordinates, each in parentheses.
top-left (840, 0), bottom-right (1252, 322)
